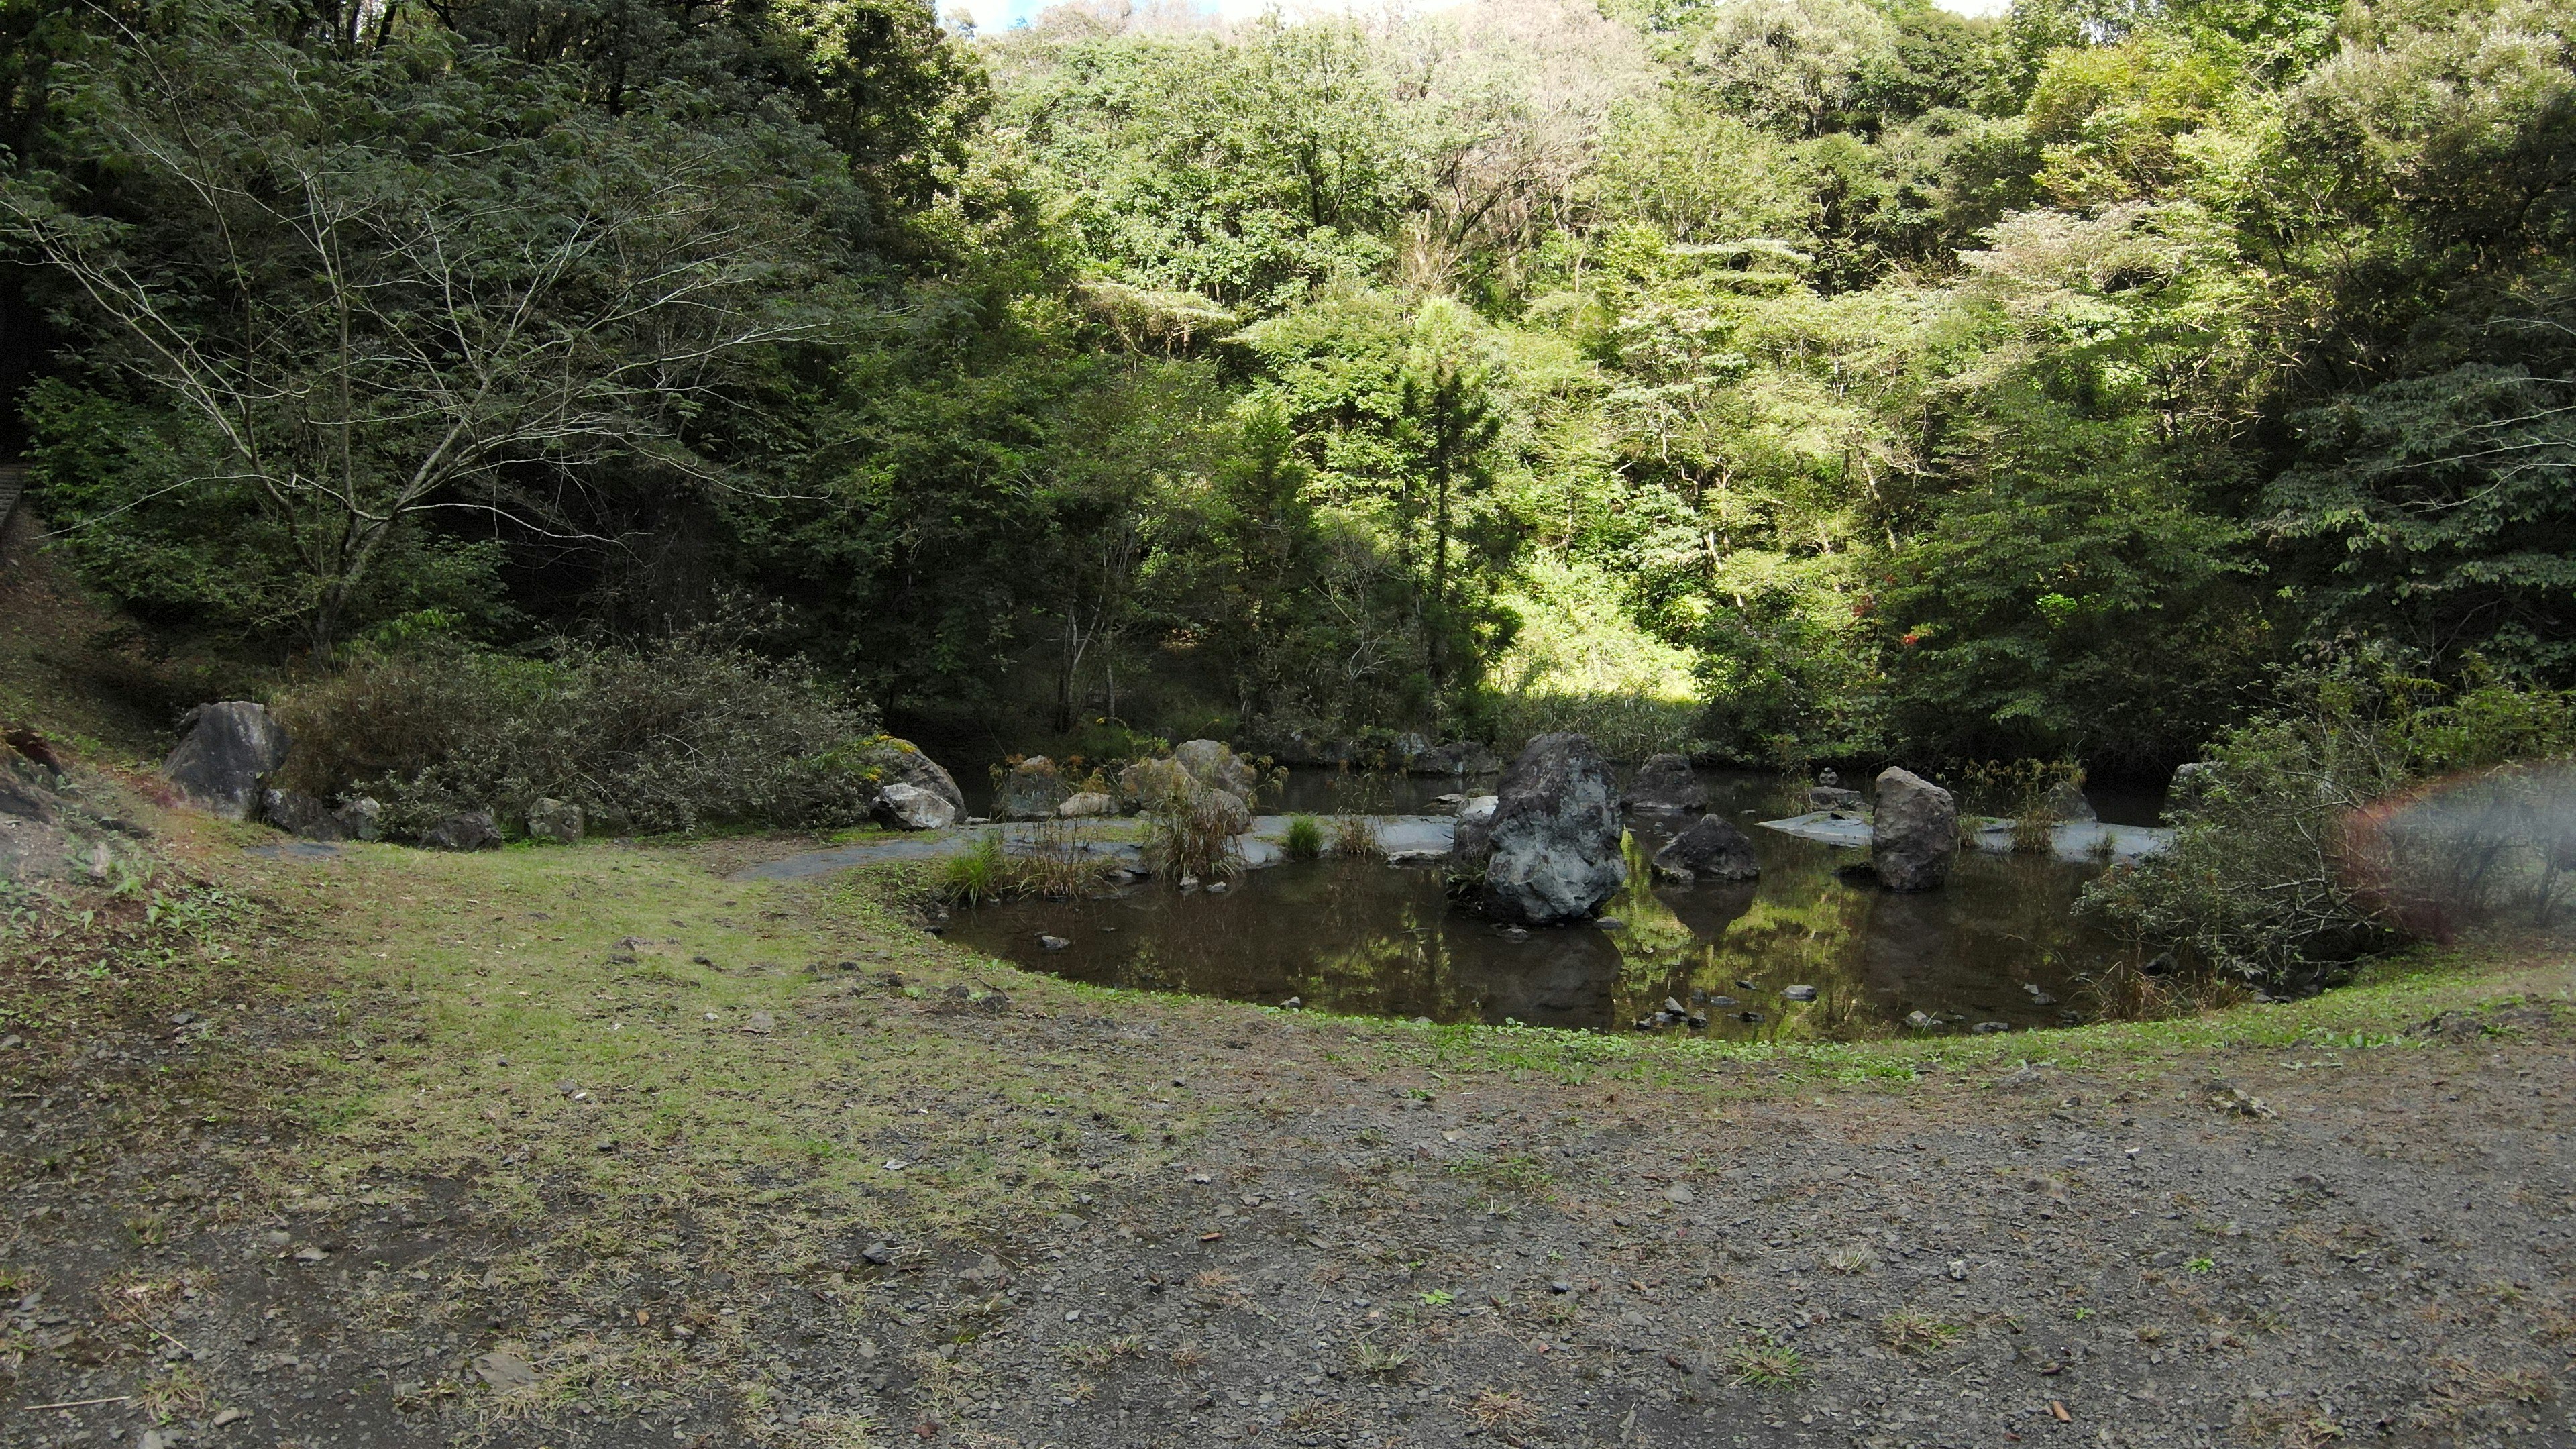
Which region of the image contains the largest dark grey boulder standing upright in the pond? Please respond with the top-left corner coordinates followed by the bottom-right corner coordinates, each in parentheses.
top-left (1460, 735), bottom-right (1628, 926)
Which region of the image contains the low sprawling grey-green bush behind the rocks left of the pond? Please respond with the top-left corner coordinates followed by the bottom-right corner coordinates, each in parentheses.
top-left (273, 634), bottom-right (876, 835)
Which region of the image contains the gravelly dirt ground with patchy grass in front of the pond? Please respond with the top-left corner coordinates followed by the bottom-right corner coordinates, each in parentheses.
top-left (0, 822), bottom-right (2576, 1449)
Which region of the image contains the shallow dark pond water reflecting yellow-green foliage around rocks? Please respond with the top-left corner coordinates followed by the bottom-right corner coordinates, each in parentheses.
top-left (948, 773), bottom-right (2153, 1042)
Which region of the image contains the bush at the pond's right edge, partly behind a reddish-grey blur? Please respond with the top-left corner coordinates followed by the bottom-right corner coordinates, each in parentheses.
top-left (2084, 667), bottom-right (2576, 987)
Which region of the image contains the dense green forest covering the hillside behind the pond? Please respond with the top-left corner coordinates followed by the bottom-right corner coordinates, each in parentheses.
top-left (0, 0), bottom-right (2576, 771)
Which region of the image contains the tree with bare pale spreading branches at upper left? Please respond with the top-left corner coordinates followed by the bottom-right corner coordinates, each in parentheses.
top-left (0, 23), bottom-right (824, 660)
